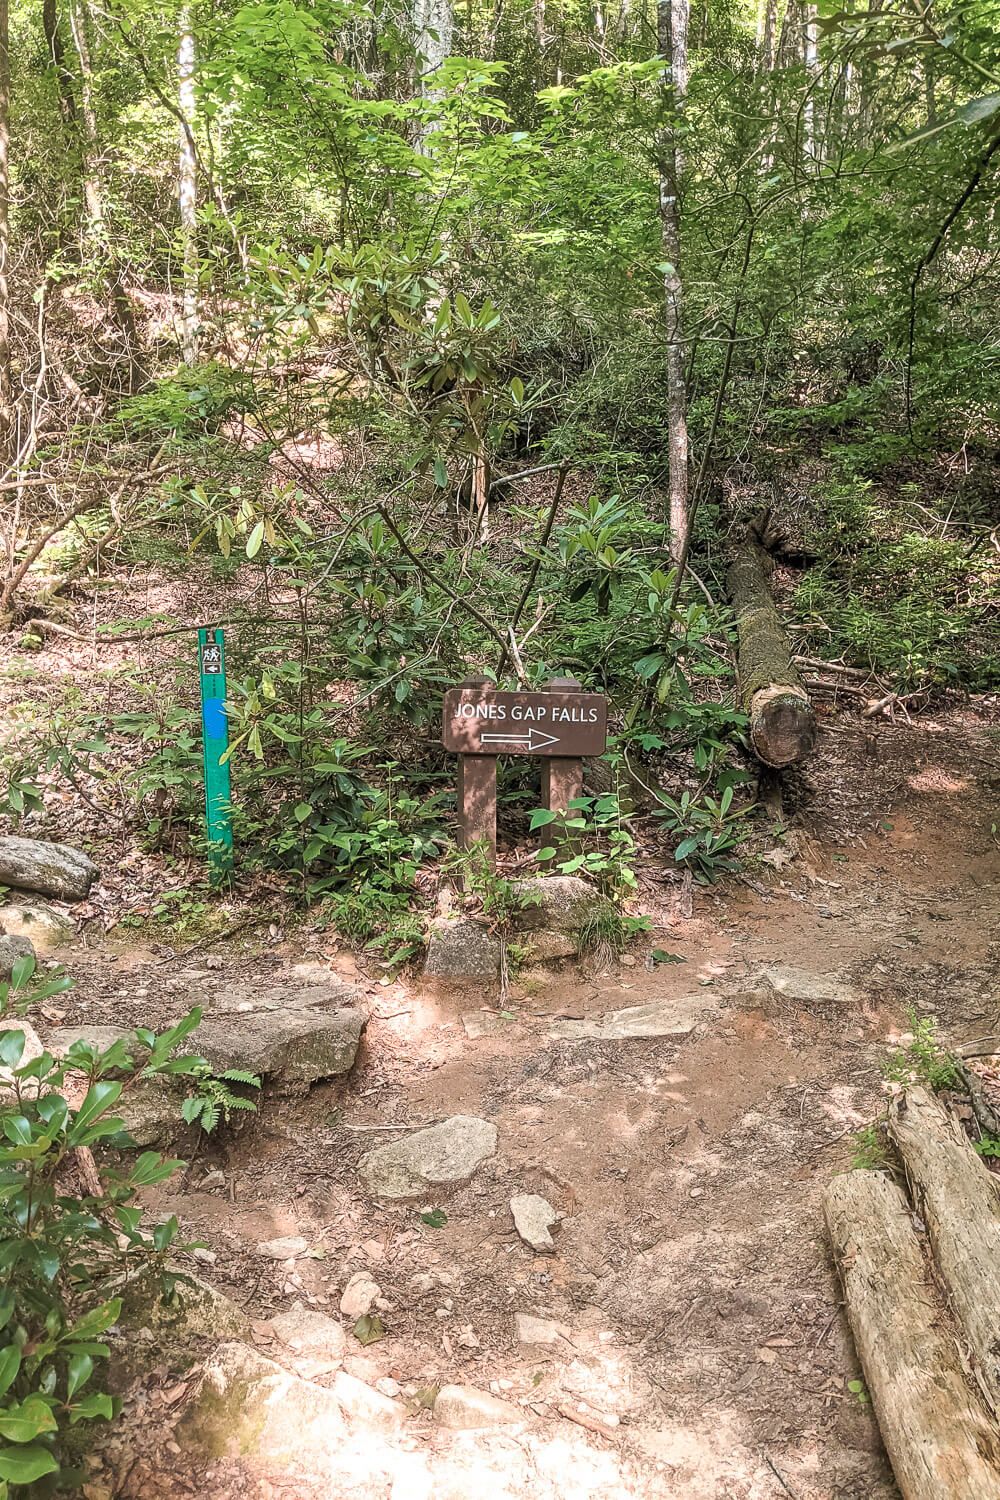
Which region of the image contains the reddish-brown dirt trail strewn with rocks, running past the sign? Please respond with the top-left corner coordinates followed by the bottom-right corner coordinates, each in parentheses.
top-left (70, 713), bottom-right (1000, 1500)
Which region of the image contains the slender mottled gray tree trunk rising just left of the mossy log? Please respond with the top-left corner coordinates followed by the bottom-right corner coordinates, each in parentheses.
top-left (657, 0), bottom-right (690, 563)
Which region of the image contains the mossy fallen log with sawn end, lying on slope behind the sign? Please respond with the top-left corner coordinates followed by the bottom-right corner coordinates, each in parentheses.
top-left (726, 537), bottom-right (816, 768)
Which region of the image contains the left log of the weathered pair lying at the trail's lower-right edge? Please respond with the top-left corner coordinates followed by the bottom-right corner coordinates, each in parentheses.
top-left (823, 1172), bottom-right (1000, 1500)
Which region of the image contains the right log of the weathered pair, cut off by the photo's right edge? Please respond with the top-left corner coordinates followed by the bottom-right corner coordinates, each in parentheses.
top-left (889, 1089), bottom-right (1000, 1416)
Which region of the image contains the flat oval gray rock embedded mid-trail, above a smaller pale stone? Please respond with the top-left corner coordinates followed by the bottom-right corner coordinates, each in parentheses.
top-left (358, 1115), bottom-right (496, 1199)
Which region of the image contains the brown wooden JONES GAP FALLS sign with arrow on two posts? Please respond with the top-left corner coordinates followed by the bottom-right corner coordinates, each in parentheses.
top-left (441, 677), bottom-right (607, 863)
